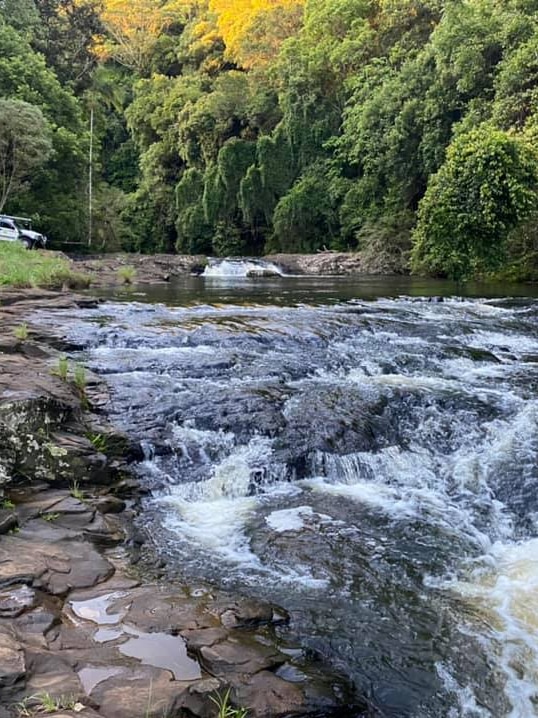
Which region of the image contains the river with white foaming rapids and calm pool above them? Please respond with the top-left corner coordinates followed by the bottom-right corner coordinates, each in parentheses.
top-left (52, 270), bottom-right (538, 718)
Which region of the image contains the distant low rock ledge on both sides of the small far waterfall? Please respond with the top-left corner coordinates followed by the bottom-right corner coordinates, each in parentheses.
top-left (71, 252), bottom-right (366, 287)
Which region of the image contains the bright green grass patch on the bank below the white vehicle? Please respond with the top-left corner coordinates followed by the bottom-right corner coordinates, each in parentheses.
top-left (0, 241), bottom-right (90, 289)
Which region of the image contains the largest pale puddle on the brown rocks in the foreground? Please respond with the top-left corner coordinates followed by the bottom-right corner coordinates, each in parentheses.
top-left (118, 625), bottom-right (202, 681)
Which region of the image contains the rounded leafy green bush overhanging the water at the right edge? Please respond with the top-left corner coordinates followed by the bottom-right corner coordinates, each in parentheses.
top-left (412, 125), bottom-right (538, 279)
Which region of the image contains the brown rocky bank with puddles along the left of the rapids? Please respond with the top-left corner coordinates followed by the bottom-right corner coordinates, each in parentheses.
top-left (0, 290), bottom-right (367, 718)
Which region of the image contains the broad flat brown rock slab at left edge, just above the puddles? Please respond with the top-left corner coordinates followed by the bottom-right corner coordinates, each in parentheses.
top-left (0, 536), bottom-right (114, 596)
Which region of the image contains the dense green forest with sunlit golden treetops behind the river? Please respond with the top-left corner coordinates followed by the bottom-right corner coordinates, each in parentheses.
top-left (0, 0), bottom-right (538, 279)
